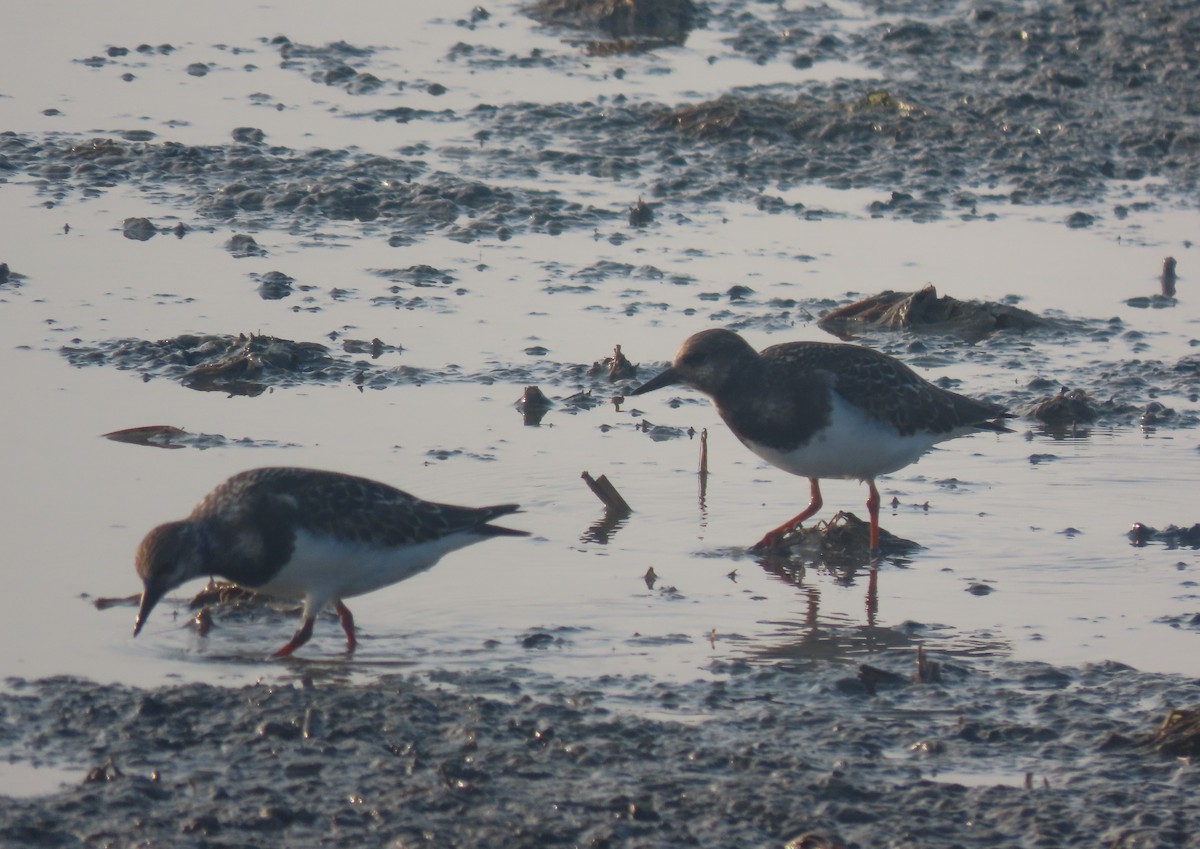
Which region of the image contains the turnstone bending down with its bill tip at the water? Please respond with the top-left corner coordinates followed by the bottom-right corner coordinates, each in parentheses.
top-left (133, 468), bottom-right (529, 657)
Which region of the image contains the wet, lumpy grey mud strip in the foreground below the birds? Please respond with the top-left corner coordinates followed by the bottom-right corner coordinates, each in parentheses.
top-left (0, 652), bottom-right (1200, 848)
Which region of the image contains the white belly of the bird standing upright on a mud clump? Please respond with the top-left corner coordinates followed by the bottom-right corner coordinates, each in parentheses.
top-left (746, 396), bottom-right (952, 481)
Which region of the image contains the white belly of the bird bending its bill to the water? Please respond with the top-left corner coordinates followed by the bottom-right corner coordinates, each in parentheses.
top-left (254, 531), bottom-right (486, 614)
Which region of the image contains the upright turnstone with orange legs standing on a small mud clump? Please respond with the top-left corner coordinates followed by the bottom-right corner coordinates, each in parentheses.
top-left (632, 329), bottom-right (1009, 550)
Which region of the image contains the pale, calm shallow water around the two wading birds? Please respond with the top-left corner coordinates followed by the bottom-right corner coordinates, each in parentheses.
top-left (0, 5), bottom-right (1200, 700)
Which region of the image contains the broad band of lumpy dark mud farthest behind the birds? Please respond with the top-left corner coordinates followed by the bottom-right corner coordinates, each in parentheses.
top-left (7, 0), bottom-right (1200, 237)
